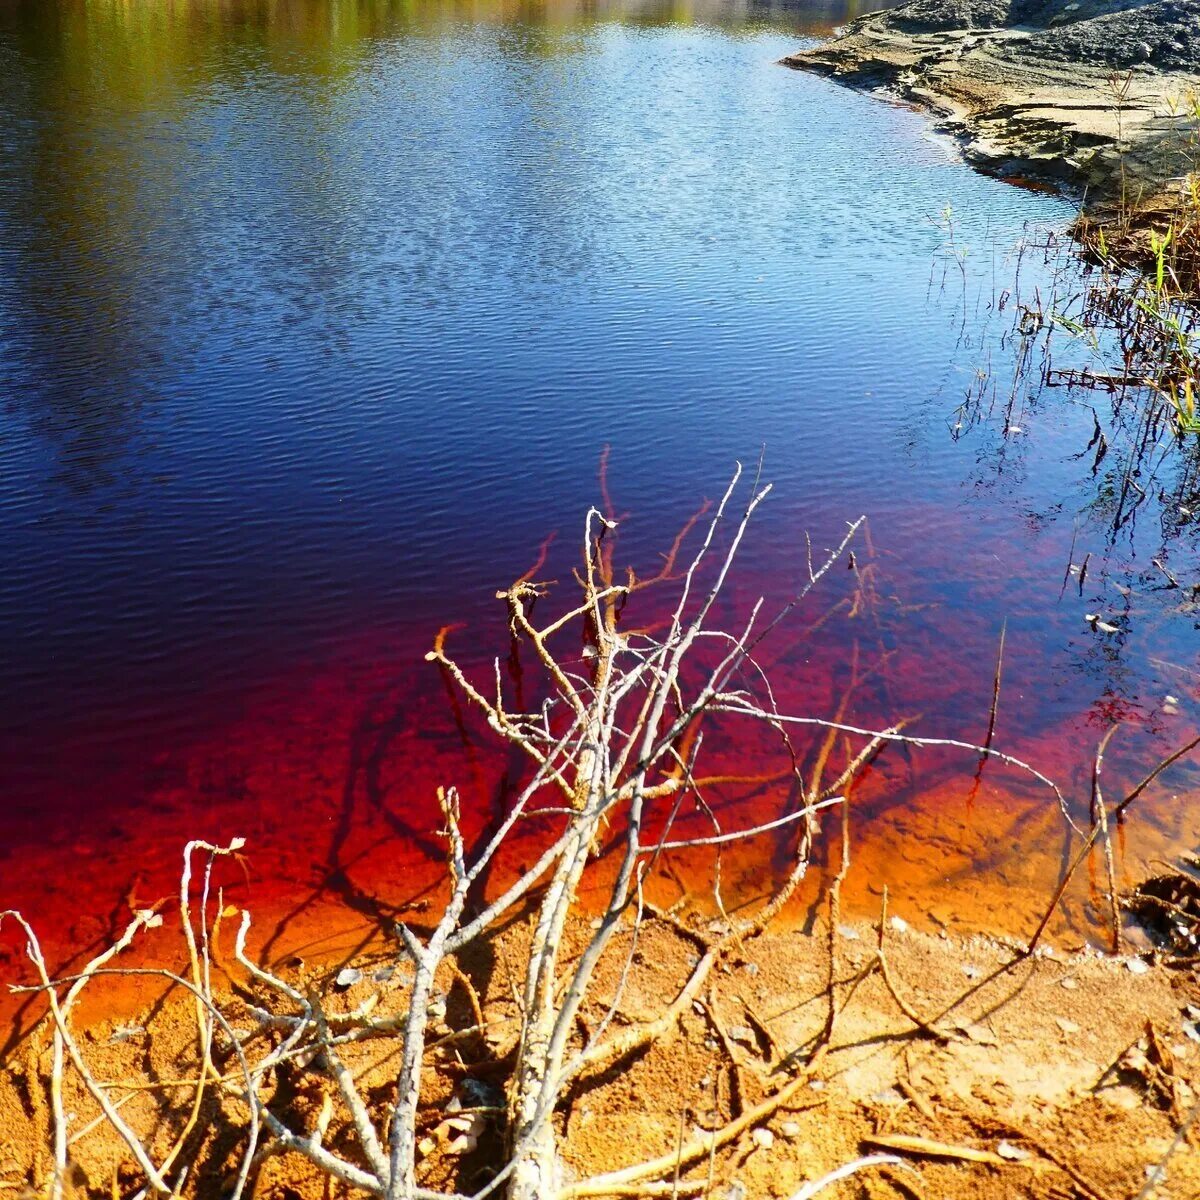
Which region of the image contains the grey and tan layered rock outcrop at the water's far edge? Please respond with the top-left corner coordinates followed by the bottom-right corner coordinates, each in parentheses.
top-left (784, 0), bottom-right (1200, 205)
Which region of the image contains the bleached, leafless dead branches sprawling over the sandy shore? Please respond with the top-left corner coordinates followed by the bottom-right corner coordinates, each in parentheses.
top-left (2, 468), bottom-right (1089, 1200)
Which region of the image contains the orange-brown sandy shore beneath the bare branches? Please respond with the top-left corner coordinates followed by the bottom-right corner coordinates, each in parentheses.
top-left (0, 916), bottom-right (1200, 1200)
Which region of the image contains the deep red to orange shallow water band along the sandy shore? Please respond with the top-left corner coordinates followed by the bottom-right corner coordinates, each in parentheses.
top-left (0, 499), bottom-right (1200, 1041)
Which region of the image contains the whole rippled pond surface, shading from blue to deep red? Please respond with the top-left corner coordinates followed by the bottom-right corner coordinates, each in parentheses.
top-left (0, 0), bottom-right (1200, 979)
